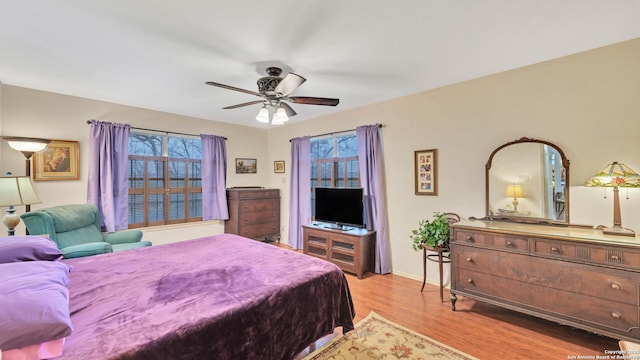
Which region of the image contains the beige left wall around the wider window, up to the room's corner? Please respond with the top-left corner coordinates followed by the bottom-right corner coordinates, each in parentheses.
top-left (0, 85), bottom-right (271, 244)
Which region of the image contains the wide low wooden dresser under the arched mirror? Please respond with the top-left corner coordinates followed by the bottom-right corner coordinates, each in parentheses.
top-left (451, 220), bottom-right (640, 342)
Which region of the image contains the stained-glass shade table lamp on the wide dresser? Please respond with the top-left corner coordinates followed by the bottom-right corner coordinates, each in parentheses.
top-left (585, 161), bottom-right (640, 236)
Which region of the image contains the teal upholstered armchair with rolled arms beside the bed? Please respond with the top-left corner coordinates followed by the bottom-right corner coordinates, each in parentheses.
top-left (20, 204), bottom-right (151, 259)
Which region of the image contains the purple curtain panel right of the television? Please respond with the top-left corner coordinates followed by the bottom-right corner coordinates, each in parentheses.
top-left (356, 125), bottom-right (391, 274)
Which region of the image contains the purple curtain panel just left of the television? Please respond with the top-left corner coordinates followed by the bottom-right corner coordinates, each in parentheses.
top-left (289, 136), bottom-right (311, 250)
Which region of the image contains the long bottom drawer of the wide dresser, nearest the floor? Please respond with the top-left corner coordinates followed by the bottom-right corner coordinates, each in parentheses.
top-left (454, 269), bottom-right (640, 332)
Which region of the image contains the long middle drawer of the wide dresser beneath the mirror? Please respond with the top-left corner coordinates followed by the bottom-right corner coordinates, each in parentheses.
top-left (452, 246), bottom-right (640, 306)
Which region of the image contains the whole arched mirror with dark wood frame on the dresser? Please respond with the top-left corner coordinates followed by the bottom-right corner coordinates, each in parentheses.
top-left (486, 137), bottom-right (569, 225)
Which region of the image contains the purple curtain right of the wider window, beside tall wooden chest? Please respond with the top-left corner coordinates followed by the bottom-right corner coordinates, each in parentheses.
top-left (200, 135), bottom-right (229, 220)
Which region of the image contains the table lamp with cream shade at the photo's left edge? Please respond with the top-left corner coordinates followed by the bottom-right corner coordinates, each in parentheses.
top-left (0, 176), bottom-right (40, 236)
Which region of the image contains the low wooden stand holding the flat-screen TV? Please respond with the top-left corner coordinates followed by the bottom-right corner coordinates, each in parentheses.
top-left (302, 223), bottom-right (376, 279)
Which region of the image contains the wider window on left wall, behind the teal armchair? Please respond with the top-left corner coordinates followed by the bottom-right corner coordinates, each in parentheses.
top-left (128, 132), bottom-right (202, 228)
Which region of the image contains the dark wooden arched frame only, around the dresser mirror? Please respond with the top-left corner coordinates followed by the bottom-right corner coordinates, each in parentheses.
top-left (485, 137), bottom-right (570, 225)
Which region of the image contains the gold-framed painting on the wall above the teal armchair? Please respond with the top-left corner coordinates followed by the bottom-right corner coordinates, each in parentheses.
top-left (32, 140), bottom-right (80, 181)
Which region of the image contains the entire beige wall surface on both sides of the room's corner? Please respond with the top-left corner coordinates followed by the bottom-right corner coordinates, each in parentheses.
top-left (0, 39), bottom-right (640, 281)
